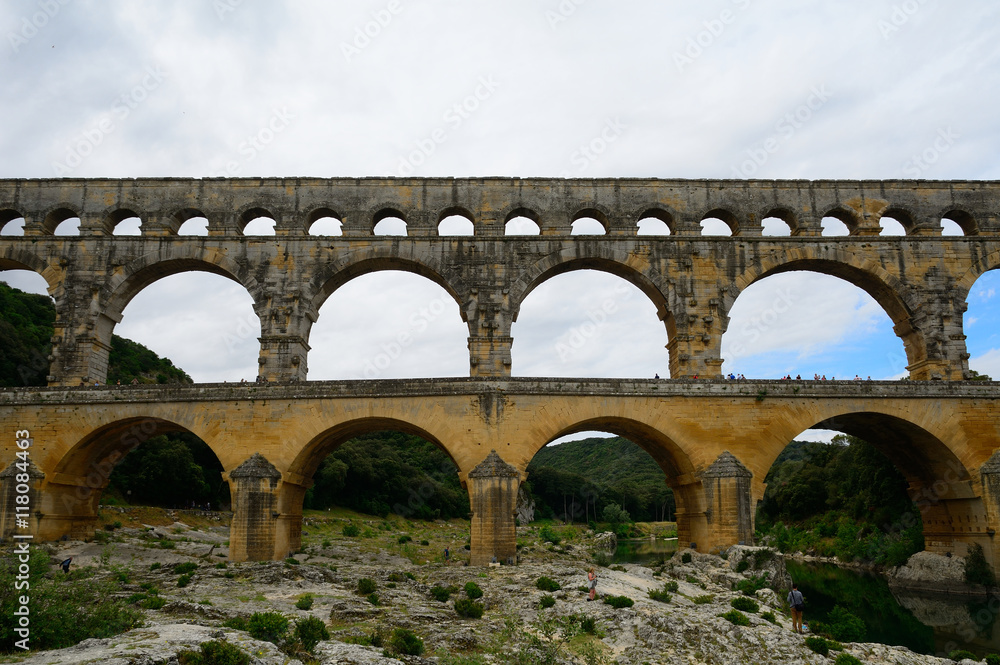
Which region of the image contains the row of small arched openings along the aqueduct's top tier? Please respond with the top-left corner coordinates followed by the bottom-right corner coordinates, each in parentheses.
top-left (0, 205), bottom-right (979, 236)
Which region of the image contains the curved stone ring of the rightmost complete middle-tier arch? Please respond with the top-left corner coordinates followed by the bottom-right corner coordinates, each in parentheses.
top-left (714, 249), bottom-right (927, 374)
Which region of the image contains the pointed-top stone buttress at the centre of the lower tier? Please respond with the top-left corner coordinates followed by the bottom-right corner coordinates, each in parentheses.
top-left (468, 450), bottom-right (521, 566)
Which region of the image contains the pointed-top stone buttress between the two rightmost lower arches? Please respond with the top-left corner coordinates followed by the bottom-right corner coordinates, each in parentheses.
top-left (698, 450), bottom-right (753, 552)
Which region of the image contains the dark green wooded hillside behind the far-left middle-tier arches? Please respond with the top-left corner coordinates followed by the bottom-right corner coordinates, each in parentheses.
top-left (0, 282), bottom-right (191, 387)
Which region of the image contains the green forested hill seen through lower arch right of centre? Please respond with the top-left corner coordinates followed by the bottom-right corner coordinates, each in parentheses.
top-left (528, 437), bottom-right (674, 521)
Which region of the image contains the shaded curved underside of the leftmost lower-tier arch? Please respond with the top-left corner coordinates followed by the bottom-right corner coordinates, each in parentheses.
top-left (38, 416), bottom-right (222, 540)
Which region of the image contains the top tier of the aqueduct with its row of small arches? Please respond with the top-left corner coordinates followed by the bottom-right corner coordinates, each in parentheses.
top-left (0, 179), bottom-right (1000, 238)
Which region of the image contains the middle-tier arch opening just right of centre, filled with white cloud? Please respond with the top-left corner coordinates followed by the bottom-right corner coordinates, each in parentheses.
top-left (511, 268), bottom-right (670, 378)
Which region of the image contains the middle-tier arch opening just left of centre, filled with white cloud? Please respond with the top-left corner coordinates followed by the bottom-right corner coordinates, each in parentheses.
top-left (309, 268), bottom-right (469, 380)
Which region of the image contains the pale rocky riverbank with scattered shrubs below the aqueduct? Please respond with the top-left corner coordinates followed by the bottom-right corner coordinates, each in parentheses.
top-left (9, 518), bottom-right (968, 665)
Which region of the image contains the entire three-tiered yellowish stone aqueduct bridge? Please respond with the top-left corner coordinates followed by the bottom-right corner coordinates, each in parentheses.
top-left (0, 178), bottom-right (1000, 563)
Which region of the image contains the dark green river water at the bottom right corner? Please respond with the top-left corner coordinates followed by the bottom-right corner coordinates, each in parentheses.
top-left (787, 561), bottom-right (1000, 656)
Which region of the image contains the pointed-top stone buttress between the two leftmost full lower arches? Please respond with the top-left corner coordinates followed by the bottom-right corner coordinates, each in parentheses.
top-left (229, 453), bottom-right (286, 561)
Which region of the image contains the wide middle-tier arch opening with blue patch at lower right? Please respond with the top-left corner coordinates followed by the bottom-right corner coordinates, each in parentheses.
top-left (722, 262), bottom-right (915, 380)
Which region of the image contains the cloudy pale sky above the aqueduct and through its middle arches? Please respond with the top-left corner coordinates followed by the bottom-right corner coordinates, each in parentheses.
top-left (0, 0), bottom-right (1000, 440)
